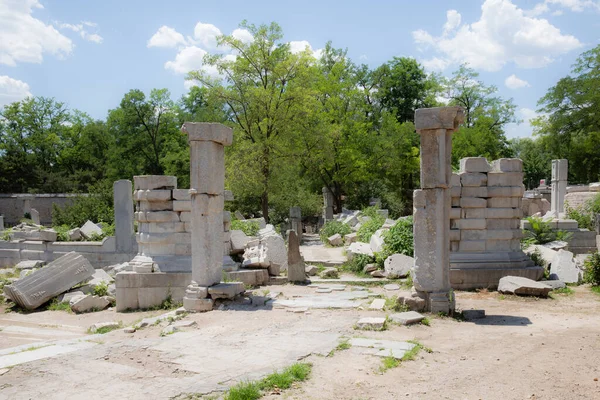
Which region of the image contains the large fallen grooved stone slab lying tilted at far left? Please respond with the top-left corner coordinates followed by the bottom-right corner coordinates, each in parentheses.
top-left (4, 252), bottom-right (95, 310)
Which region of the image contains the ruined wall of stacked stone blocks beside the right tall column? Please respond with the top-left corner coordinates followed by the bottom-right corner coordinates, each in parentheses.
top-left (450, 157), bottom-right (541, 289)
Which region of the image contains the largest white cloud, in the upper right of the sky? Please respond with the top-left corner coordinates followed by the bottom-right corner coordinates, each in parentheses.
top-left (413, 0), bottom-right (582, 71)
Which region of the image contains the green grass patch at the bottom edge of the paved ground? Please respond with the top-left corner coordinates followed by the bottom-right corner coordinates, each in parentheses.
top-left (223, 363), bottom-right (312, 400)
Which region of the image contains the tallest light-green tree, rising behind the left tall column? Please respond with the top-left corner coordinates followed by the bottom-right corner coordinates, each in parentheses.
top-left (188, 21), bottom-right (313, 220)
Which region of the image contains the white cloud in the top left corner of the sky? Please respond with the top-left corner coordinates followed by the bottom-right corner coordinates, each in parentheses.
top-left (0, 0), bottom-right (74, 66)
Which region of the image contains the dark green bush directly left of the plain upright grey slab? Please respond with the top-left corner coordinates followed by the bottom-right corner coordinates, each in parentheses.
top-left (52, 181), bottom-right (114, 228)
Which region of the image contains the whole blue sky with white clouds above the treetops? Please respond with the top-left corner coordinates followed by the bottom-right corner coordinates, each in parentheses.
top-left (0, 0), bottom-right (600, 138)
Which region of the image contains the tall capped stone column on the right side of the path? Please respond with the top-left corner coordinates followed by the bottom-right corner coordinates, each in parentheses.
top-left (413, 107), bottom-right (464, 313)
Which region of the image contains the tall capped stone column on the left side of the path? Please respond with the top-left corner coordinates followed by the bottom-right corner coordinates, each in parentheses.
top-left (181, 122), bottom-right (244, 311)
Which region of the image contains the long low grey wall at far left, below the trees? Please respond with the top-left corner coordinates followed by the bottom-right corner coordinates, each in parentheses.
top-left (0, 193), bottom-right (78, 227)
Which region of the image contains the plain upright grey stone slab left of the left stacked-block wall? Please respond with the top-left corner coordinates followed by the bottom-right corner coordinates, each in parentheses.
top-left (113, 179), bottom-right (135, 253)
